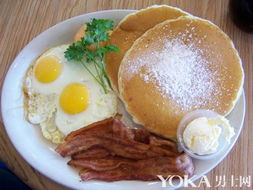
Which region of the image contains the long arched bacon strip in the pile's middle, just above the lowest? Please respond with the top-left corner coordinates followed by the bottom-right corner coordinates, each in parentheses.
top-left (56, 135), bottom-right (177, 159)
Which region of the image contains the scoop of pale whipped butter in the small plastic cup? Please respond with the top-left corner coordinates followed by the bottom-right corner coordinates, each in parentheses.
top-left (183, 116), bottom-right (235, 155)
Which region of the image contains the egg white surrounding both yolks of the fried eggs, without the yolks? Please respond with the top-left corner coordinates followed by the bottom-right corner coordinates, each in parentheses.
top-left (24, 45), bottom-right (117, 143)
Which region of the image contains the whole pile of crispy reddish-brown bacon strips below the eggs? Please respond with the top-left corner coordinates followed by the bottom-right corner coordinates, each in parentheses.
top-left (56, 116), bottom-right (194, 181)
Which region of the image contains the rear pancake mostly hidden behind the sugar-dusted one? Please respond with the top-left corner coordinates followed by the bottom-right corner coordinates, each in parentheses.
top-left (105, 5), bottom-right (187, 91)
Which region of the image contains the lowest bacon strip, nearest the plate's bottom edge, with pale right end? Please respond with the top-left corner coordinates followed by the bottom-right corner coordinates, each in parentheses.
top-left (77, 154), bottom-right (194, 181)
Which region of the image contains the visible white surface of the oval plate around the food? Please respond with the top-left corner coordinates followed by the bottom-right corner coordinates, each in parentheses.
top-left (1, 10), bottom-right (245, 190)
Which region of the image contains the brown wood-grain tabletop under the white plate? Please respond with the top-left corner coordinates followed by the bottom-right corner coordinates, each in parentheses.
top-left (0, 0), bottom-right (253, 190)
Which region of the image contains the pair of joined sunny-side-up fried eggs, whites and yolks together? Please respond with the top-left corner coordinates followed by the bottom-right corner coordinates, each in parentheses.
top-left (24, 45), bottom-right (117, 143)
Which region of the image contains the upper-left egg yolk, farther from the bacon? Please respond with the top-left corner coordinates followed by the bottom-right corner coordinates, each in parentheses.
top-left (34, 56), bottom-right (62, 83)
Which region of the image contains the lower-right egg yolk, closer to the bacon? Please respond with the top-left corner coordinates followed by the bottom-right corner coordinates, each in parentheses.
top-left (60, 83), bottom-right (89, 114)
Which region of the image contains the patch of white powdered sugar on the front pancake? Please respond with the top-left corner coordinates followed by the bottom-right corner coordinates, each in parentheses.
top-left (126, 39), bottom-right (217, 111)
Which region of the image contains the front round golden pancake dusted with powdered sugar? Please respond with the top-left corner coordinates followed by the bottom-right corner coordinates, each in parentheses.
top-left (119, 16), bottom-right (244, 139)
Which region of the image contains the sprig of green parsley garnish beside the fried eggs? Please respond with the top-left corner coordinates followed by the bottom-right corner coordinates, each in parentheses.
top-left (64, 18), bottom-right (119, 93)
